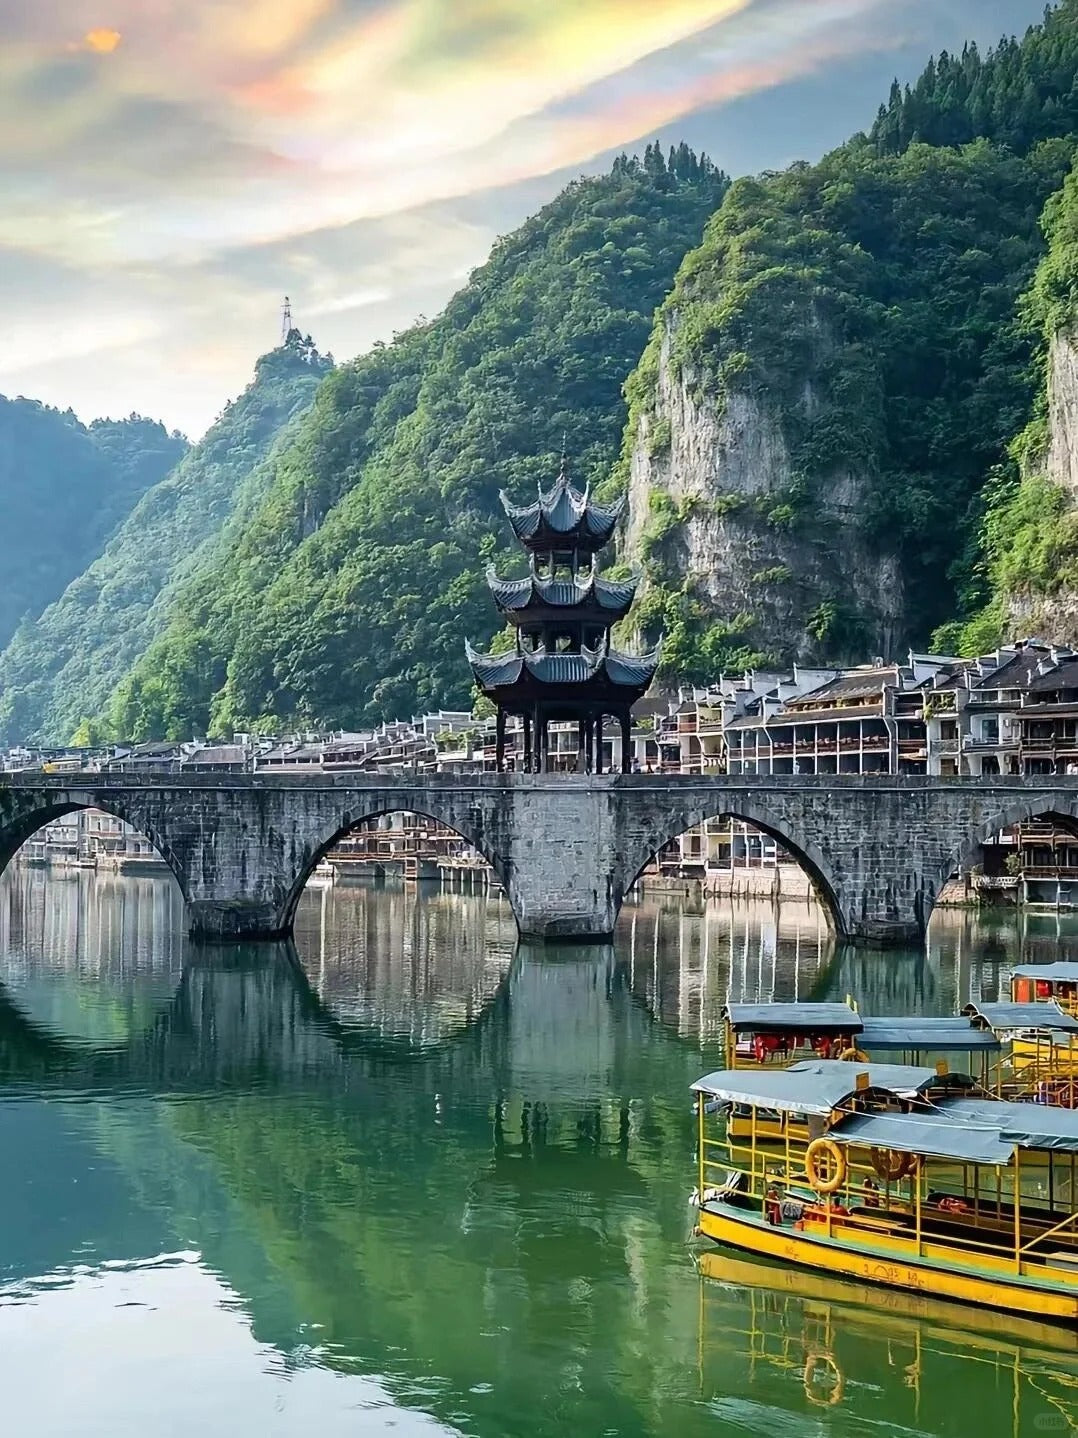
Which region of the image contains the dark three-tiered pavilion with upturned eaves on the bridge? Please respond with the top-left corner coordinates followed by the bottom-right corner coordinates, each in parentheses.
top-left (466, 456), bottom-right (658, 772)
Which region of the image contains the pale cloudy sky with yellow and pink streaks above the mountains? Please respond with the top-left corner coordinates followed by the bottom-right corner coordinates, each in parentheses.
top-left (0, 0), bottom-right (1044, 437)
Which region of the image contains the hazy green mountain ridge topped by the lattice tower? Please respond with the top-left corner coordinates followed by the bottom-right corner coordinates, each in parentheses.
top-left (0, 331), bottom-right (331, 741)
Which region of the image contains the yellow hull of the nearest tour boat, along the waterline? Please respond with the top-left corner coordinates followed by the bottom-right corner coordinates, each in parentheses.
top-left (699, 1204), bottom-right (1078, 1323)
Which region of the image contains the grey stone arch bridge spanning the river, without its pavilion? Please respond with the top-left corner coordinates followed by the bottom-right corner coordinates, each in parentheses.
top-left (0, 771), bottom-right (1078, 945)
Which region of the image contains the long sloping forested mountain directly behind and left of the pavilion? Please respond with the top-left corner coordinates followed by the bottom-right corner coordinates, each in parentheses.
top-left (101, 147), bottom-right (727, 738)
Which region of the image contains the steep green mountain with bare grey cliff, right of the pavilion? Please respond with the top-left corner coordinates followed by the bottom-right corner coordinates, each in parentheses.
top-left (617, 0), bottom-right (1078, 677)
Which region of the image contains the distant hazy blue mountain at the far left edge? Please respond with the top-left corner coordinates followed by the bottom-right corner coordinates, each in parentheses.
top-left (0, 397), bottom-right (187, 658)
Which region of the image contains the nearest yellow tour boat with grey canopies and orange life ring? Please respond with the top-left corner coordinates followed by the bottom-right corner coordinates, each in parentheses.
top-left (693, 1060), bottom-right (1078, 1323)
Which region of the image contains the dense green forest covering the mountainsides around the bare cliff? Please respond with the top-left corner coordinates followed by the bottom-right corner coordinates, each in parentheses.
top-left (10, 0), bottom-right (1078, 739)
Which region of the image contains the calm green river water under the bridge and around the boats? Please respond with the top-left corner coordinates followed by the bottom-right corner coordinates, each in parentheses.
top-left (0, 870), bottom-right (1078, 1438)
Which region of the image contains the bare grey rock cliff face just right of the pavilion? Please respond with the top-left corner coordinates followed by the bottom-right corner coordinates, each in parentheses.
top-left (625, 313), bottom-right (906, 663)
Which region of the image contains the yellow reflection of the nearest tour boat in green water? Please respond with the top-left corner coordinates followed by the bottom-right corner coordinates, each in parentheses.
top-left (697, 1250), bottom-right (1078, 1438)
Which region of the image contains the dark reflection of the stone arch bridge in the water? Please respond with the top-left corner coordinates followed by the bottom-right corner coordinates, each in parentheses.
top-left (0, 943), bottom-right (664, 1107)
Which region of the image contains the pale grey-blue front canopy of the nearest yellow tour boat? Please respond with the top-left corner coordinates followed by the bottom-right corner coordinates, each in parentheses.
top-left (693, 1058), bottom-right (976, 1117)
